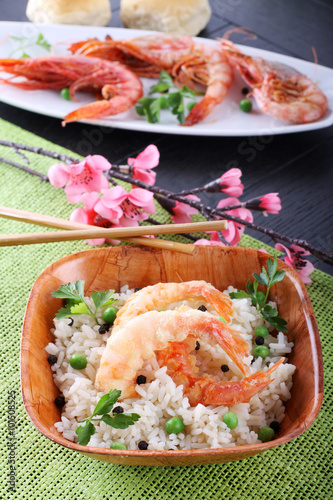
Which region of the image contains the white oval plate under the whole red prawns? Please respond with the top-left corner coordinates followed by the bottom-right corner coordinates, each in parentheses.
top-left (0, 22), bottom-right (333, 137)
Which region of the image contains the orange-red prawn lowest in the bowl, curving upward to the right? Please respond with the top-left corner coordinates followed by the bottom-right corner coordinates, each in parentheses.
top-left (158, 342), bottom-right (284, 406)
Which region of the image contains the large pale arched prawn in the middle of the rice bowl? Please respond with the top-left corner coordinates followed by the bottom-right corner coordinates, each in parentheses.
top-left (95, 309), bottom-right (249, 398)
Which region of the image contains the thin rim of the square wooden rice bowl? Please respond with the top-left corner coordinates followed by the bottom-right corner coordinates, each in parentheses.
top-left (20, 246), bottom-right (324, 458)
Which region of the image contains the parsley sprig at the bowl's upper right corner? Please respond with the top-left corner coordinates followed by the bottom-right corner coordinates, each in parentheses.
top-left (229, 256), bottom-right (288, 333)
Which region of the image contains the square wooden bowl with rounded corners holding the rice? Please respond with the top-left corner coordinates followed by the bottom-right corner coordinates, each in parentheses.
top-left (21, 246), bottom-right (323, 466)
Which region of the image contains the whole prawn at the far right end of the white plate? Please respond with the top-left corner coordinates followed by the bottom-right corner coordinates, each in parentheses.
top-left (221, 39), bottom-right (327, 123)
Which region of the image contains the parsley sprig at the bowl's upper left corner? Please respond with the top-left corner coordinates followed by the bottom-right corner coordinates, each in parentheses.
top-left (52, 280), bottom-right (117, 324)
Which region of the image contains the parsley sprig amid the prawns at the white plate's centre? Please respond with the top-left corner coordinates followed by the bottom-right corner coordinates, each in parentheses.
top-left (135, 70), bottom-right (200, 123)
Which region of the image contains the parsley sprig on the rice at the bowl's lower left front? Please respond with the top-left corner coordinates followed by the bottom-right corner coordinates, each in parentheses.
top-left (76, 389), bottom-right (140, 446)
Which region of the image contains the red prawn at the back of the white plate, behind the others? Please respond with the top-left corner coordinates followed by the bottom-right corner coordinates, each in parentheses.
top-left (68, 33), bottom-right (194, 78)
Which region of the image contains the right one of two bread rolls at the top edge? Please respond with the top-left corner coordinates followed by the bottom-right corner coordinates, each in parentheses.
top-left (120, 0), bottom-right (212, 36)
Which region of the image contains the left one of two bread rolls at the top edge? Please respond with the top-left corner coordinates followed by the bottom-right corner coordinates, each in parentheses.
top-left (26, 0), bottom-right (111, 26)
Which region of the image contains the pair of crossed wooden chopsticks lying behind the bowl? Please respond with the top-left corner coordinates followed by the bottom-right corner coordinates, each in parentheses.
top-left (0, 207), bottom-right (228, 254)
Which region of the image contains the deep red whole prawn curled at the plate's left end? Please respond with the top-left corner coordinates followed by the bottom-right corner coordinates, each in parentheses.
top-left (0, 56), bottom-right (143, 125)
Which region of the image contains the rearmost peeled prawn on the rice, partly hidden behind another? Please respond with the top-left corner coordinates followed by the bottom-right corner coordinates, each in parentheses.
top-left (113, 281), bottom-right (233, 335)
